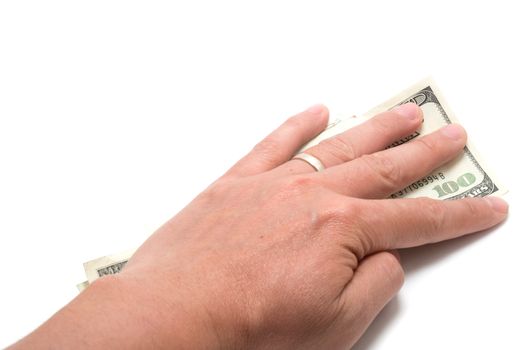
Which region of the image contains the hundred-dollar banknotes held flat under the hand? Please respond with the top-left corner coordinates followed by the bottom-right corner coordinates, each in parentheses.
top-left (77, 78), bottom-right (506, 291)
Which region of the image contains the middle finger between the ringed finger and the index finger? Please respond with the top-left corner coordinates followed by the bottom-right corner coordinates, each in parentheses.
top-left (317, 124), bottom-right (466, 198)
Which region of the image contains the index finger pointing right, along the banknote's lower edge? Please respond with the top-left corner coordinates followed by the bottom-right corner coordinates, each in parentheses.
top-left (354, 196), bottom-right (508, 253)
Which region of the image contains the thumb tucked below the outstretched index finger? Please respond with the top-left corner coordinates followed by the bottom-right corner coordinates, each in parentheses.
top-left (342, 252), bottom-right (404, 348)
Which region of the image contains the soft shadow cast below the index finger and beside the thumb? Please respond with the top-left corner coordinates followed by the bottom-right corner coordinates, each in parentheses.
top-left (352, 223), bottom-right (502, 350)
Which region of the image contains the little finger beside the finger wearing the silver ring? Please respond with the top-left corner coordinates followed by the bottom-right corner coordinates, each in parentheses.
top-left (226, 105), bottom-right (328, 176)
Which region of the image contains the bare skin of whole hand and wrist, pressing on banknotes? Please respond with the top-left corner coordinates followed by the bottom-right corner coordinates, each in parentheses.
top-left (12, 104), bottom-right (508, 349)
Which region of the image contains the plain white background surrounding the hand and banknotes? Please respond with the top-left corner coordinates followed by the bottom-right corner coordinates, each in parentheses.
top-left (0, 0), bottom-right (528, 349)
